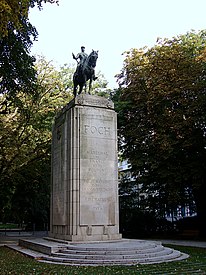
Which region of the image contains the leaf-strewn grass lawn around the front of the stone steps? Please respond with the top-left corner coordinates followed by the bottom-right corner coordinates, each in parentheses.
top-left (0, 245), bottom-right (206, 275)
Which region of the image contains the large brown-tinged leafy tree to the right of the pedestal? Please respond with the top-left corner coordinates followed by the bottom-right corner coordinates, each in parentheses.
top-left (116, 31), bottom-right (206, 236)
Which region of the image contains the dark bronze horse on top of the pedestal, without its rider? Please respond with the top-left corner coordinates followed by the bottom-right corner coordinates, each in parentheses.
top-left (73, 50), bottom-right (98, 97)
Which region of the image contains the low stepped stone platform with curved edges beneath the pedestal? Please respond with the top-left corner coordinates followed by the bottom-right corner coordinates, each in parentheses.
top-left (8, 238), bottom-right (189, 266)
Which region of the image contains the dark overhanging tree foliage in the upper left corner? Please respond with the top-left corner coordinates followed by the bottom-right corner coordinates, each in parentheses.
top-left (0, 0), bottom-right (57, 112)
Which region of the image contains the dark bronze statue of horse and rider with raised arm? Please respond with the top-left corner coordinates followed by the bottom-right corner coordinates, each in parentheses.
top-left (72, 46), bottom-right (98, 97)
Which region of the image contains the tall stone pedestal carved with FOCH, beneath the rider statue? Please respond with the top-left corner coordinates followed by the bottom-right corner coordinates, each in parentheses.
top-left (49, 95), bottom-right (121, 241)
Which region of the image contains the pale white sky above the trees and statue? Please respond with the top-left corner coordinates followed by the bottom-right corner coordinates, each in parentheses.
top-left (29, 0), bottom-right (206, 89)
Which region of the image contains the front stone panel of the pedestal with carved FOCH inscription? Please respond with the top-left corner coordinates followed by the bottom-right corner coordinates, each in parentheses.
top-left (80, 108), bottom-right (117, 226)
